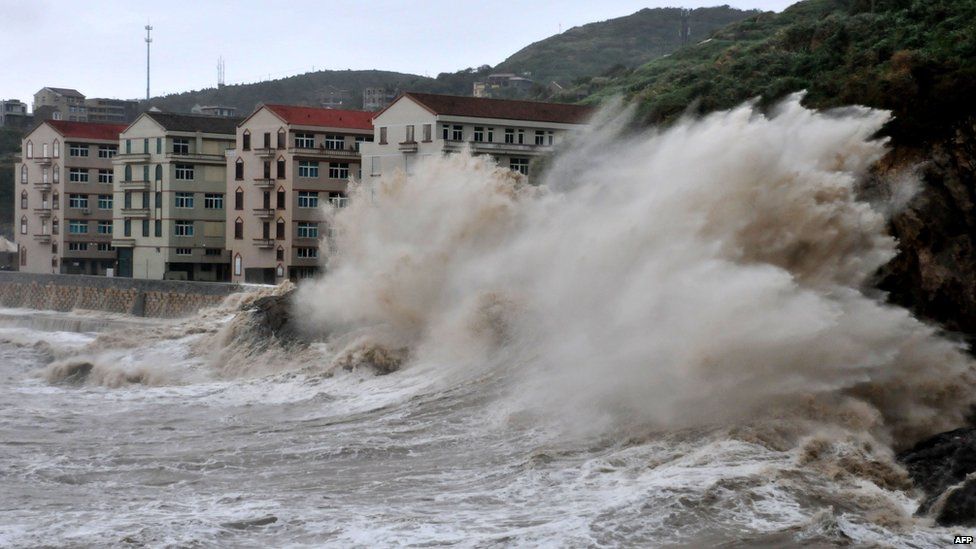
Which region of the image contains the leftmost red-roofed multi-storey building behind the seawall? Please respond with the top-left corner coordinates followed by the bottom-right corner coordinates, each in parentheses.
top-left (14, 120), bottom-right (125, 275)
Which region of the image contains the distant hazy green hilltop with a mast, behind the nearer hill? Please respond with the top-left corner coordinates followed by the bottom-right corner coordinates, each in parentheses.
top-left (494, 6), bottom-right (759, 86)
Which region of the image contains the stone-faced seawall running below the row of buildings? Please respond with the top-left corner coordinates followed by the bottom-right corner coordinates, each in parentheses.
top-left (0, 272), bottom-right (245, 318)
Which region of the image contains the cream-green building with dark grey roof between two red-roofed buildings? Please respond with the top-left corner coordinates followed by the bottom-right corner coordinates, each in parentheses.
top-left (112, 112), bottom-right (240, 281)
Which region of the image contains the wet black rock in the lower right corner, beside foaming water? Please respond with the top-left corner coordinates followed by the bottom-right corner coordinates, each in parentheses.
top-left (898, 428), bottom-right (976, 526)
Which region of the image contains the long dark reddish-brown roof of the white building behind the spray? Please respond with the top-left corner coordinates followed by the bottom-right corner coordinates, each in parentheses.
top-left (404, 92), bottom-right (594, 124)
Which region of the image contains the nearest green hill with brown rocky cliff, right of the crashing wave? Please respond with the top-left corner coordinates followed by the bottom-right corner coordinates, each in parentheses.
top-left (586, 0), bottom-right (976, 342)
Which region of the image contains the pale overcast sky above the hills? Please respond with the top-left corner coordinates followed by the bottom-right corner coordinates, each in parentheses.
top-left (0, 0), bottom-right (796, 109)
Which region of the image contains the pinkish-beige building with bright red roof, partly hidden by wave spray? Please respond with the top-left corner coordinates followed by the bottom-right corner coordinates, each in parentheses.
top-left (226, 105), bottom-right (373, 284)
